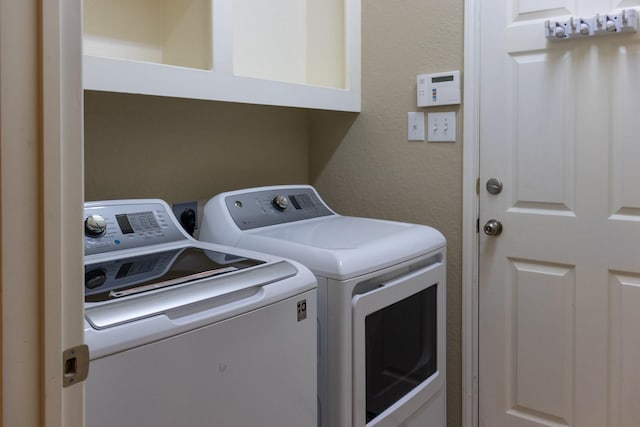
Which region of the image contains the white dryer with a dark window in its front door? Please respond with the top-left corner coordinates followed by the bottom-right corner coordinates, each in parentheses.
top-left (199, 185), bottom-right (446, 427)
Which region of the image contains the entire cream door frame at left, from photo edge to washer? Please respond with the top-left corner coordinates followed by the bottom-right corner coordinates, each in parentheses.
top-left (0, 0), bottom-right (84, 427)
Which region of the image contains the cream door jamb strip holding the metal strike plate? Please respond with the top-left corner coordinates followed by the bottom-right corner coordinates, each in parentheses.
top-left (40, 0), bottom-right (84, 427)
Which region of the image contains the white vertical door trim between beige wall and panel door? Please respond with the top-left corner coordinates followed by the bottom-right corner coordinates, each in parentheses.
top-left (462, 0), bottom-right (480, 427)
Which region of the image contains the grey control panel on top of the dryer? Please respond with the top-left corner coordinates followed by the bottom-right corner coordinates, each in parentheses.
top-left (225, 187), bottom-right (335, 230)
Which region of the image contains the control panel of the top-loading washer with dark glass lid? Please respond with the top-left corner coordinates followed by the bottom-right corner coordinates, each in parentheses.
top-left (84, 200), bottom-right (188, 255)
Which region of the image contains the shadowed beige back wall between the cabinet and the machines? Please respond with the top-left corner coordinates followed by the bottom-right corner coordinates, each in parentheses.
top-left (85, 92), bottom-right (309, 202)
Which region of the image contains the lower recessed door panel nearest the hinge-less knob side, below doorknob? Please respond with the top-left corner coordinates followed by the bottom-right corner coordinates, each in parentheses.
top-left (509, 260), bottom-right (575, 425)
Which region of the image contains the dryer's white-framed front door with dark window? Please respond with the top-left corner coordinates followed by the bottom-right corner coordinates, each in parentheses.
top-left (352, 262), bottom-right (445, 427)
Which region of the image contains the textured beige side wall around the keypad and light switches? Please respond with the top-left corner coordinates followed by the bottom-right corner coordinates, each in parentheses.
top-left (309, 0), bottom-right (463, 426)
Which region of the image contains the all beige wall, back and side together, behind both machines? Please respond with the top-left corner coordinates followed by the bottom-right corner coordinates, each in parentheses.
top-left (85, 0), bottom-right (463, 426)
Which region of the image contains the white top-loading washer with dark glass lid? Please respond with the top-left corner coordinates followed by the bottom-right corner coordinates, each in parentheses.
top-left (84, 199), bottom-right (317, 427)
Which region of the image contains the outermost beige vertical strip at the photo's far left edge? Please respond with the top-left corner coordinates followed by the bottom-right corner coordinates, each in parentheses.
top-left (0, 0), bottom-right (42, 427)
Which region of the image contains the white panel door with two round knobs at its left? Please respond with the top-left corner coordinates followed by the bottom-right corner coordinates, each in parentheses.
top-left (479, 0), bottom-right (640, 427)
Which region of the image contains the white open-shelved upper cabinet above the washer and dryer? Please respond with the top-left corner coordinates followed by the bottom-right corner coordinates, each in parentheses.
top-left (83, 0), bottom-right (360, 111)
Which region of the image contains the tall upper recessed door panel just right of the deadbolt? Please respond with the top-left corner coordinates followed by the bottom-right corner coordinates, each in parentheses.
top-left (510, 52), bottom-right (575, 212)
